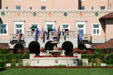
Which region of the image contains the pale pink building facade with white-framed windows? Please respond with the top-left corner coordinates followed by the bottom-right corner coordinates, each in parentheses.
top-left (0, 0), bottom-right (113, 47)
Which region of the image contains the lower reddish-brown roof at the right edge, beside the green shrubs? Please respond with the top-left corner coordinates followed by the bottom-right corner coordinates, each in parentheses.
top-left (92, 39), bottom-right (113, 49)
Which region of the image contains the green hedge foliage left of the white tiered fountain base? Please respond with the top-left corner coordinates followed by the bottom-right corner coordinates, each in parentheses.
top-left (0, 50), bottom-right (29, 66)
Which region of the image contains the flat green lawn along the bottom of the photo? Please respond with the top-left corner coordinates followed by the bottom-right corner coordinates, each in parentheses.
top-left (0, 68), bottom-right (113, 75)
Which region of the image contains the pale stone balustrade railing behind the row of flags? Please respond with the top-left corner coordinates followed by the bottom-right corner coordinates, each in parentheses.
top-left (11, 31), bottom-right (92, 42)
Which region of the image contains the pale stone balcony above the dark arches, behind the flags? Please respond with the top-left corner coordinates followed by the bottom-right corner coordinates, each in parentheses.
top-left (10, 31), bottom-right (92, 44)
